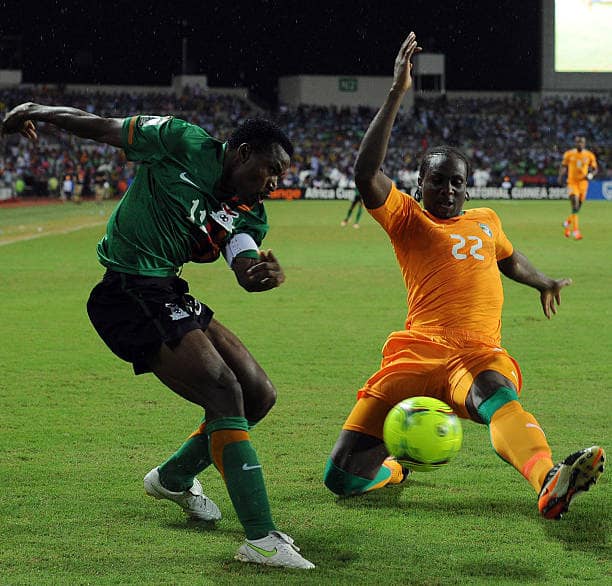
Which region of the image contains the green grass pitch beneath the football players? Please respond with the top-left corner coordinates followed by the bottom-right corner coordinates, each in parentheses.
top-left (0, 201), bottom-right (612, 585)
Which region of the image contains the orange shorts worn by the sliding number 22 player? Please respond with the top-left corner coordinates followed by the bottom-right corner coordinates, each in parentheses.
top-left (343, 328), bottom-right (522, 439)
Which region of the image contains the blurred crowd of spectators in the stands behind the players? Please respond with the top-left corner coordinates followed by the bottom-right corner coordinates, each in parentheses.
top-left (0, 86), bottom-right (612, 200)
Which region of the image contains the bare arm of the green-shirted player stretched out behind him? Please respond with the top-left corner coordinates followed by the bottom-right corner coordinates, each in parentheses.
top-left (0, 102), bottom-right (123, 147)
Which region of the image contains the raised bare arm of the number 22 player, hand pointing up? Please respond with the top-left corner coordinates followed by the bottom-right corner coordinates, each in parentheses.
top-left (355, 32), bottom-right (421, 209)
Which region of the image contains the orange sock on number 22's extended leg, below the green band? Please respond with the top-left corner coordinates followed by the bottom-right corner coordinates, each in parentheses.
top-left (489, 401), bottom-right (553, 493)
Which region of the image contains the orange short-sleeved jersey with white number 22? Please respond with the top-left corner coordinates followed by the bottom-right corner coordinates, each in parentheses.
top-left (369, 185), bottom-right (513, 344)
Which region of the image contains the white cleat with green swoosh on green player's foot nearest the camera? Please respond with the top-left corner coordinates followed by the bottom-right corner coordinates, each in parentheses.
top-left (234, 531), bottom-right (315, 570)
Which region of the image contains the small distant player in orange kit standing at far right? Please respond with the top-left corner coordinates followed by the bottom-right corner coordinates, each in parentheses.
top-left (558, 135), bottom-right (597, 240)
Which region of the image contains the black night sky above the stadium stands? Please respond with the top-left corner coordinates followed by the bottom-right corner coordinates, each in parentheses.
top-left (0, 0), bottom-right (541, 102)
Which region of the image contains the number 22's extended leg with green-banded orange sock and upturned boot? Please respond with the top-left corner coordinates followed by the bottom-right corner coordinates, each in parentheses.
top-left (466, 370), bottom-right (605, 519)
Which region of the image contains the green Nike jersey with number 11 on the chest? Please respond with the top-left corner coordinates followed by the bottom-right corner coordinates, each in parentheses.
top-left (97, 116), bottom-right (268, 277)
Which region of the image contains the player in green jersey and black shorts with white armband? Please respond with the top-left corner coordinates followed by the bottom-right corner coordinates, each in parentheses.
top-left (2, 103), bottom-right (314, 569)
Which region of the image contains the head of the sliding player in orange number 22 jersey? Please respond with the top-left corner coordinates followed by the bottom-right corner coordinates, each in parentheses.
top-left (420, 154), bottom-right (467, 220)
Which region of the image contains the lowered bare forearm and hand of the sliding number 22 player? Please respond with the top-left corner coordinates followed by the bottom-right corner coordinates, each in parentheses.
top-left (497, 250), bottom-right (572, 319)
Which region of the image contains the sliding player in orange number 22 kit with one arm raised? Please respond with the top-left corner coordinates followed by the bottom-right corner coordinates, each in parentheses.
top-left (324, 33), bottom-right (605, 519)
